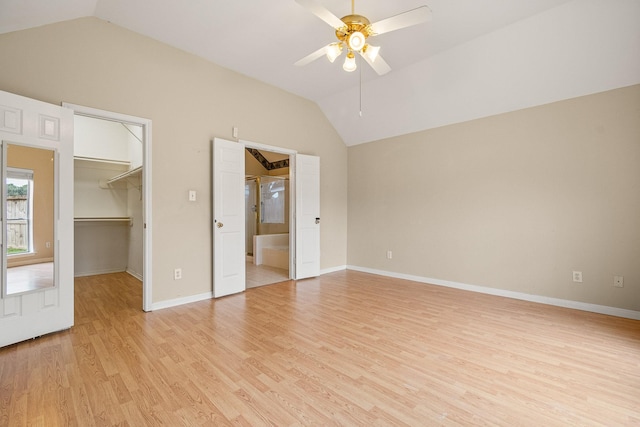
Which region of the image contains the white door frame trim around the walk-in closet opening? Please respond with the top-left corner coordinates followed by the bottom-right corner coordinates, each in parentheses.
top-left (62, 102), bottom-right (153, 311)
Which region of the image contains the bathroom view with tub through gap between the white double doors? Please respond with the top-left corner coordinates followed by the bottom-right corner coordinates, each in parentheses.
top-left (244, 147), bottom-right (291, 289)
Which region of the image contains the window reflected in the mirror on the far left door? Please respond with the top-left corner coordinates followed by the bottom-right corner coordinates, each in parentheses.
top-left (6, 168), bottom-right (33, 255)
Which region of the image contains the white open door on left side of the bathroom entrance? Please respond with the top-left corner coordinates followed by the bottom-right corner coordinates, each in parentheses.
top-left (212, 138), bottom-right (245, 298)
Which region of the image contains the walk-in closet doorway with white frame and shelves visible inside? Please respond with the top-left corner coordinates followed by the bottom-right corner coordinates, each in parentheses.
top-left (63, 104), bottom-right (152, 311)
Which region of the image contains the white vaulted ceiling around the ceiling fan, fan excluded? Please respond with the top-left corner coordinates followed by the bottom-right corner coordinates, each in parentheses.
top-left (0, 0), bottom-right (640, 145)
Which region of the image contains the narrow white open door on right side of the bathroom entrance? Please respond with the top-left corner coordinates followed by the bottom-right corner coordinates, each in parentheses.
top-left (295, 154), bottom-right (320, 279)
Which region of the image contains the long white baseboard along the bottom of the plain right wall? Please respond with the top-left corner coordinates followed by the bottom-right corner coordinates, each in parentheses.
top-left (347, 265), bottom-right (640, 320)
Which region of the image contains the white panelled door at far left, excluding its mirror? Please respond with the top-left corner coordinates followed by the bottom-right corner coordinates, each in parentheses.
top-left (0, 91), bottom-right (73, 347)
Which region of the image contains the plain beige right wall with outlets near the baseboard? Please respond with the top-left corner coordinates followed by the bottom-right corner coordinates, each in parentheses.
top-left (348, 86), bottom-right (640, 310)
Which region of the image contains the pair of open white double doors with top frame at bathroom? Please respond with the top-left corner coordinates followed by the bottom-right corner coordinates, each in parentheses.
top-left (212, 138), bottom-right (320, 298)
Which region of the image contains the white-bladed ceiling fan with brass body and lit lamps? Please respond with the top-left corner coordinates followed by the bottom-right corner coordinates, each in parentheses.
top-left (295, 0), bottom-right (431, 75)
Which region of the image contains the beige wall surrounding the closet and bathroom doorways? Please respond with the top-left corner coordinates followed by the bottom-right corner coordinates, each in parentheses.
top-left (0, 18), bottom-right (347, 302)
